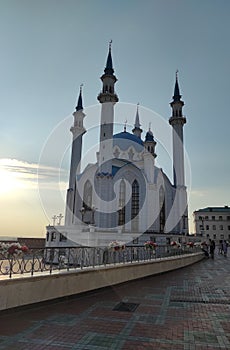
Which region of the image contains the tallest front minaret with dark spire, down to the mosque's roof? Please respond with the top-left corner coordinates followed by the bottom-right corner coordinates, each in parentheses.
top-left (97, 41), bottom-right (118, 174)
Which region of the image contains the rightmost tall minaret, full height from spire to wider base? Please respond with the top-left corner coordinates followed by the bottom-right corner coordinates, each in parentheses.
top-left (169, 71), bottom-right (188, 234)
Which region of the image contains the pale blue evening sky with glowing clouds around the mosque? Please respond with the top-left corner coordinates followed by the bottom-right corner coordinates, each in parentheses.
top-left (0, 0), bottom-right (230, 237)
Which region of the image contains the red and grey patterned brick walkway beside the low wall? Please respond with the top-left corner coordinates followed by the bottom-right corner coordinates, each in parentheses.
top-left (0, 255), bottom-right (230, 350)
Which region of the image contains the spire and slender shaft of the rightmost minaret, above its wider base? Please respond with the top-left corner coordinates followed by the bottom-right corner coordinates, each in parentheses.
top-left (169, 72), bottom-right (186, 187)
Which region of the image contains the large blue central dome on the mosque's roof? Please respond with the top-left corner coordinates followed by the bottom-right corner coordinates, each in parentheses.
top-left (113, 131), bottom-right (144, 152)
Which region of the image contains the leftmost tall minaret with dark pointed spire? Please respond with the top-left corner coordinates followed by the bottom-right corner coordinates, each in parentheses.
top-left (65, 85), bottom-right (86, 225)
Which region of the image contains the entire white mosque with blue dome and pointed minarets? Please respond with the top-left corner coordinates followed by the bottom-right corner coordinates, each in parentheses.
top-left (46, 44), bottom-right (188, 247)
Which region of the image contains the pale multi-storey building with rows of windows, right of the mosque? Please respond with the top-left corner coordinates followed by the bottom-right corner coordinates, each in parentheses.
top-left (193, 205), bottom-right (230, 241)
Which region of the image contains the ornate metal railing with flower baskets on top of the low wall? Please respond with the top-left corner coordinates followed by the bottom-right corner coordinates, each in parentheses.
top-left (0, 245), bottom-right (201, 278)
